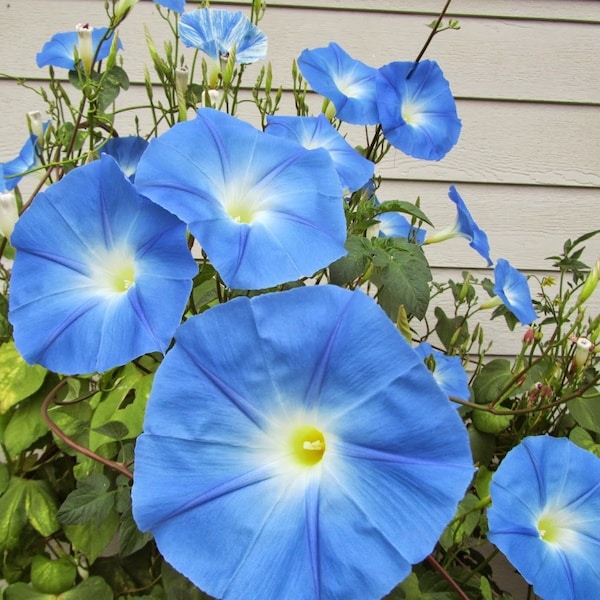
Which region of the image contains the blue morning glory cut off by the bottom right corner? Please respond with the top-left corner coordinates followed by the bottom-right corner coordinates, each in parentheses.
top-left (488, 436), bottom-right (600, 600)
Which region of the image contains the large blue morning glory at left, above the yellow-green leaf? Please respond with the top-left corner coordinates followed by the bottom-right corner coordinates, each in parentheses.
top-left (9, 155), bottom-right (197, 374)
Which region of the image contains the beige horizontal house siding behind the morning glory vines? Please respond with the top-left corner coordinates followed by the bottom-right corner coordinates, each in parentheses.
top-left (0, 0), bottom-right (600, 353)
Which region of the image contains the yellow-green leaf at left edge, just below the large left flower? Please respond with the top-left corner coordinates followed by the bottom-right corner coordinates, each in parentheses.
top-left (0, 342), bottom-right (46, 413)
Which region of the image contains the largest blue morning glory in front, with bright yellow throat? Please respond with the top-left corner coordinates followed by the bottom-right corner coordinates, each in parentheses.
top-left (132, 286), bottom-right (473, 600)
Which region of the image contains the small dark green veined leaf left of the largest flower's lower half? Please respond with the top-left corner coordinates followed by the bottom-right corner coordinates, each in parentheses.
top-left (57, 473), bottom-right (115, 526)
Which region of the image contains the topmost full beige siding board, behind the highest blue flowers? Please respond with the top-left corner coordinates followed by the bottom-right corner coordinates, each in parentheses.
top-left (0, 0), bottom-right (600, 104)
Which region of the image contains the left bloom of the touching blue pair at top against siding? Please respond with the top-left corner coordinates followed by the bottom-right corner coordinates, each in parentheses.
top-left (298, 42), bottom-right (379, 125)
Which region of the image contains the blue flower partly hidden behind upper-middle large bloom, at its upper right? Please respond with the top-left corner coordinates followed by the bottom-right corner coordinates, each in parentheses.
top-left (265, 114), bottom-right (375, 193)
